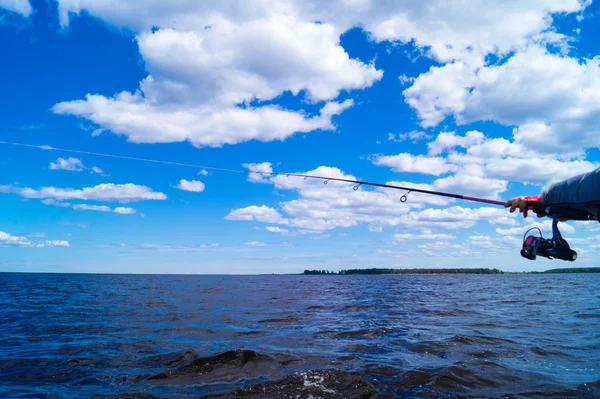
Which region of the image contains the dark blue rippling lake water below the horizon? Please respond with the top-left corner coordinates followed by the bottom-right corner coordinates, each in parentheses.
top-left (0, 273), bottom-right (600, 398)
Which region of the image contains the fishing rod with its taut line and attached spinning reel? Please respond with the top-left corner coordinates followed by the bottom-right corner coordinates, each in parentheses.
top-left (0, 140), bottom-right (598, 261)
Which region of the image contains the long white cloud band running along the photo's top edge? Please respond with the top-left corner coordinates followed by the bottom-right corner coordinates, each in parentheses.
top-left (59, 0), bottom-right (589, 62)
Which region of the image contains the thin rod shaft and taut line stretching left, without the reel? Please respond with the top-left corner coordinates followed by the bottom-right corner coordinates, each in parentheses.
top-left (0, 140), bottom-right (506, 206)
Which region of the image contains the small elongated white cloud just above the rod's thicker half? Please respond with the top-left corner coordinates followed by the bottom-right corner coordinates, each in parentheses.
top-left (371, 153), bottom-right (456, 176)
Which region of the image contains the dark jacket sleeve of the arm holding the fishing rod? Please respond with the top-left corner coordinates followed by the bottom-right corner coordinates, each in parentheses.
top-left (541, 168), bottom-right (600, 219)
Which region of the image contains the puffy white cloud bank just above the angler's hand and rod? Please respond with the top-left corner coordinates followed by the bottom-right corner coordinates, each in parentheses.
top-left (371, 130), bottom-right (600, 195)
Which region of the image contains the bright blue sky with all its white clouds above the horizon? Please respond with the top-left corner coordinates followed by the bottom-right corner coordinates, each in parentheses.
top-left (0, 0), bottom-right (600, 273)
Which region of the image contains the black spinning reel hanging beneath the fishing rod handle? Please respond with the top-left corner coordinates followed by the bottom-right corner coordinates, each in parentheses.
top-left (521, 218), bottom-right (577, 262)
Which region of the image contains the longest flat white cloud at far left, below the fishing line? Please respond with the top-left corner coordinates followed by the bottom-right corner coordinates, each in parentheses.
top-left (11, 183), bottom-right (167, 202)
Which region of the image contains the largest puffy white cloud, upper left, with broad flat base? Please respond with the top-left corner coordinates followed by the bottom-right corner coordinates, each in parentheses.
top-left (53, 1), bottom-right (382, 147)
